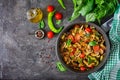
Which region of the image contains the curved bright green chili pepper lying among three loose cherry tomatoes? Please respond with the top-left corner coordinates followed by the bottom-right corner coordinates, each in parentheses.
top-left (48, 11), bottom-right (63, 33)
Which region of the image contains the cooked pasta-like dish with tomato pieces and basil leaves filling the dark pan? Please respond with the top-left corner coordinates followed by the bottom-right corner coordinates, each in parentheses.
top-left (60, 24), bottom-right (106, 71)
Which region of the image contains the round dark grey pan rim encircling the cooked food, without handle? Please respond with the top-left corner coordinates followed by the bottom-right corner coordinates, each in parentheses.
top-left (56, 22), bottom-right (110, 74)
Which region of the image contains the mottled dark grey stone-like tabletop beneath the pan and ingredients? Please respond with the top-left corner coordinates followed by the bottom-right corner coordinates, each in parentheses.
top-left (0, 0), bottom-right (119, 80)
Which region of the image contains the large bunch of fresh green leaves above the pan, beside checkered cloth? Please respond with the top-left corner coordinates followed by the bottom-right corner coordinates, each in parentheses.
top-left (69, 0), bottom-right (118, 23)
